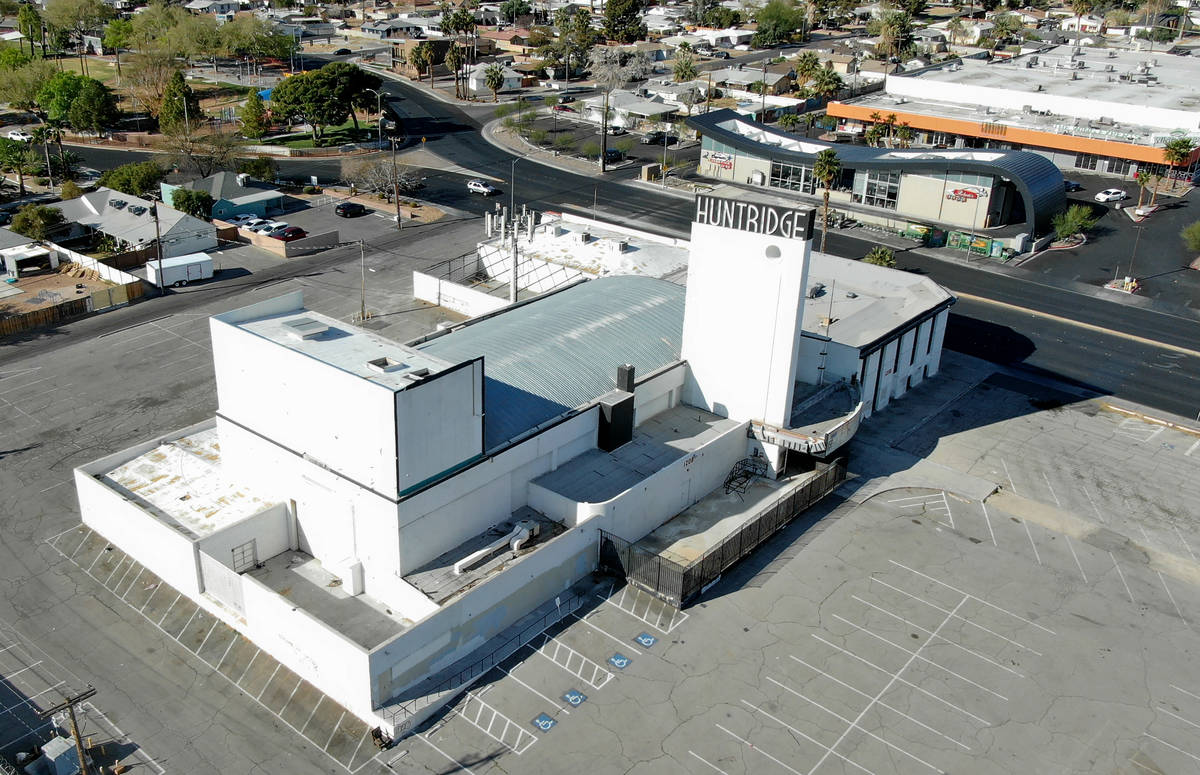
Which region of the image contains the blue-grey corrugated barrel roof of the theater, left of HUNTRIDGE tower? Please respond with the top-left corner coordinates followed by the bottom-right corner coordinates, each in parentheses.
top-left (416, 275), bottom-right (684, 451)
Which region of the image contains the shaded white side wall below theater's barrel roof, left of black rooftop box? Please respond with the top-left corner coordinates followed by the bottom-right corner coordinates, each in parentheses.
top-left (400, 408), bottom-right (599, 575)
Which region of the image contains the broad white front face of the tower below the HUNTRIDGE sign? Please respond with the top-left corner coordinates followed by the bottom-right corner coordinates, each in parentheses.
top-left (683, 218), bottom-right (809, 427)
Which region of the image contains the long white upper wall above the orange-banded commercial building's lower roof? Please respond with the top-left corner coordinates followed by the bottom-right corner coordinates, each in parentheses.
top-left (884, 71), bottom-right (1196, 132)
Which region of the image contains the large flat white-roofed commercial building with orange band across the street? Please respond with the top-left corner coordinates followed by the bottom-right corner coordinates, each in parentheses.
top-left (828, 46), bottom-right (1200, 183)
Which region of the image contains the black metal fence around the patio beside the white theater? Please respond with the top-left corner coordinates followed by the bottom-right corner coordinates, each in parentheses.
top-left (598, 459), bottom-right (846, 608)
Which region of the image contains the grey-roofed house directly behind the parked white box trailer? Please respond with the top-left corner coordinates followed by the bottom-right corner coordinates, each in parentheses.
top-left (50, 188), bottom-right (217, 258)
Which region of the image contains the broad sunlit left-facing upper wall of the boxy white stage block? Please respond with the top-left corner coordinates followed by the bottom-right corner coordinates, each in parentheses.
top-left (210, 318), bottom-right (397, 495)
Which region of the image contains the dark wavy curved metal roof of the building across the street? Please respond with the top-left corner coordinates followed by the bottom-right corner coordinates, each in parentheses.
top-left (688, 108), bottom-right (1067, 234)
